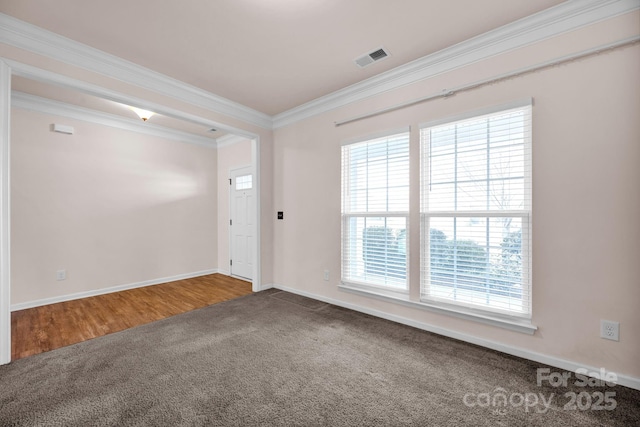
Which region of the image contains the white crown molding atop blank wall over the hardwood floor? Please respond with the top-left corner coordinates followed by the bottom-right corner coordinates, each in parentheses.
top-left (11, 91), bottom-right (216, 148)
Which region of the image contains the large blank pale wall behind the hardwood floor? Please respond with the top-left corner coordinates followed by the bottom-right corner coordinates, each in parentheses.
top-left (11, 108), bottom-right (218, 304)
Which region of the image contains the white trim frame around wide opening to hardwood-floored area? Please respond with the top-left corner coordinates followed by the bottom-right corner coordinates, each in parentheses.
top-left (0, 57), bottom-right (262, 365)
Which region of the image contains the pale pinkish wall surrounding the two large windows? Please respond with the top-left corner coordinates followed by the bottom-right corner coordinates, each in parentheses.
top-left (273, 12), bottom-right (640, 378)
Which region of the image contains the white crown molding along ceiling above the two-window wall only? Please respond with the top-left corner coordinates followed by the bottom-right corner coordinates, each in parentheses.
top-left (273, 0), bottom-right (640, 129)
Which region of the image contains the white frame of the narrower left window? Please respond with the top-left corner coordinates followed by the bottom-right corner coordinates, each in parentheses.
top-left (341, 127), bottom-right (411, 295)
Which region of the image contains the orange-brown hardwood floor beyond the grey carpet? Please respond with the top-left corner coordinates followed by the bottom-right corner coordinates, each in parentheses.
top-left (11, 274), bottom-right (251, 360)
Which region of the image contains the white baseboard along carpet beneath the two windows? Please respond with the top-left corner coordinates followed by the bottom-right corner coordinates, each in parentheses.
top-left (269, 283), bottom-right (640, 390)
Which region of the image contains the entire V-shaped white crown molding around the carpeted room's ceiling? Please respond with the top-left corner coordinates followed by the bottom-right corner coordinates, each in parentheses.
top-left (0, 0), bottom-right (640, 129)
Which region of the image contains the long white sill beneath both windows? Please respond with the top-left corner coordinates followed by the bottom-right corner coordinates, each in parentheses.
top-left (338, 282), bottom-right (538, 335)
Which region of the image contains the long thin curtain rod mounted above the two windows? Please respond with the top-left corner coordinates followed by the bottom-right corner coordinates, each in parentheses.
top-left (334, 36), bottom-right (640, 127)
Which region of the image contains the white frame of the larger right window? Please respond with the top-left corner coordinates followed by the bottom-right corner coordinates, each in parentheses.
top-left (420, 98), bottom-right (533, 321)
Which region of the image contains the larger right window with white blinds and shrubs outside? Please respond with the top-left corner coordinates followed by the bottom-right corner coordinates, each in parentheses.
top-left (420, 101), bottom-right (531, 318)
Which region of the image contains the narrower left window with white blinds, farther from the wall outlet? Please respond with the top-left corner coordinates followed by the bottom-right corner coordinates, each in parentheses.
top-left (342, 131), bottom-right (409, 292)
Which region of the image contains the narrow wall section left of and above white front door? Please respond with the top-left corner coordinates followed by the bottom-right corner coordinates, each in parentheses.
top-left (217, 139), bottom-right (251, 274)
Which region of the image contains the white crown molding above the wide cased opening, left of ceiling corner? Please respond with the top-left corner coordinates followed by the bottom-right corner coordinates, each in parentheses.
top-left (0, 13), bottom-right (272, 129)
